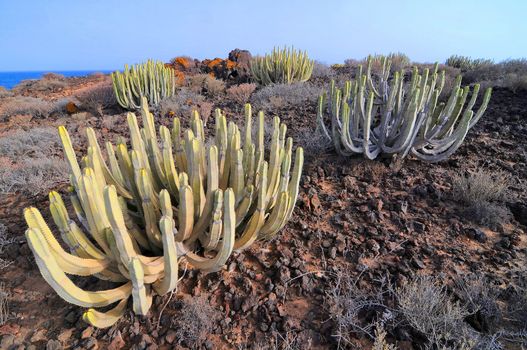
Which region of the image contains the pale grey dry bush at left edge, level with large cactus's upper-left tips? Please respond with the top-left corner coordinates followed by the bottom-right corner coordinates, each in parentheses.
top-left (0, 127), bottom-right (61, 160)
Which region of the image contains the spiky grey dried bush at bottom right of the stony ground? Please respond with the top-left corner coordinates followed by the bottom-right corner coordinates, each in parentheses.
top-left (395, 277), bottom-right (475, 349)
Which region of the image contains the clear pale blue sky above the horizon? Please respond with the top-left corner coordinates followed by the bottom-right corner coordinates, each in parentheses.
top-left (0, 0), bottom-right (527, 71)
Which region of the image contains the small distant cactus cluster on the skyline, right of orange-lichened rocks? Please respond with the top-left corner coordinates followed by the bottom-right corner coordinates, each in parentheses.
top-left (251, 48), bottom-right (315, 85)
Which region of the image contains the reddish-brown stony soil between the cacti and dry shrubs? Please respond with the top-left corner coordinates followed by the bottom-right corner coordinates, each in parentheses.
top-left (0, 74), bottom-right (527, 349)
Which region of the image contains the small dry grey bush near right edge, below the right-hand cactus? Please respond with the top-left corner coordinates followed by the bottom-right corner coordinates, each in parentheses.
top-left (452, 168), bottom-right (510, 205)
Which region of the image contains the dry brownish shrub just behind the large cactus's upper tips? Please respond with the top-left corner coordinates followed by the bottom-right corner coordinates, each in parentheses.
top-left (158, 88), bottom-right (214, 124)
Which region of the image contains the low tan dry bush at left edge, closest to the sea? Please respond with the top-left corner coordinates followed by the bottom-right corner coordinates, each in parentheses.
top-left (0, 96), bottom-right (58, 118)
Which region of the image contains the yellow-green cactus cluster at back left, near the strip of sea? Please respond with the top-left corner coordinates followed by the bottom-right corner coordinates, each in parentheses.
top-left (112, 60), bottom-right (177, 110)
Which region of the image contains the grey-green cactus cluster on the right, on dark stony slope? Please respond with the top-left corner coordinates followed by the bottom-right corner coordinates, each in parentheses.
top-left (317, 58), bottom-right (491, 162)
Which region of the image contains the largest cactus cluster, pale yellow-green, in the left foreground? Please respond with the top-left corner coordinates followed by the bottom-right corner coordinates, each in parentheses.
top-left (24, 97), bottom-right (303, 327)
